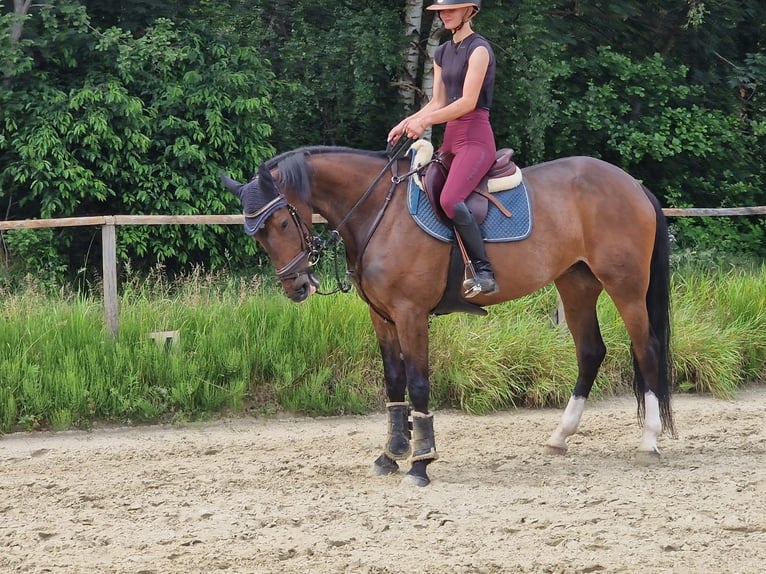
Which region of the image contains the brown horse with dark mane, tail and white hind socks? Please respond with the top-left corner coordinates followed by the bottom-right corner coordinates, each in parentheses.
top-left (222, 143), bottom-right (674, 486)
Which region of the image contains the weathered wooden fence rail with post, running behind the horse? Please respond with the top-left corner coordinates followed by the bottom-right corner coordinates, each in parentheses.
top-left (0, 206), bottom-right (766, 336)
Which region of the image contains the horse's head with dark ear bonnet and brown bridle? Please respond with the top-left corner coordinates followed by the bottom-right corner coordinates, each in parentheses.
top-left (221, 165), bottom-right (319, 302)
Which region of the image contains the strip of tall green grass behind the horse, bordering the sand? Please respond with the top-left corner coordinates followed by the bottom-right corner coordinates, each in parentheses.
top-left (0, 267), bottom-right (766, 431)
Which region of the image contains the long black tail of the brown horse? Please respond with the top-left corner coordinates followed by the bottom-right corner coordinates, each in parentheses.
top-left (633, 186), bottom-right (676, 436)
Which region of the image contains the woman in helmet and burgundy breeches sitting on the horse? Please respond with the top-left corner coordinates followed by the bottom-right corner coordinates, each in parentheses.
top-left (388, 0), bottom-right (498, 297)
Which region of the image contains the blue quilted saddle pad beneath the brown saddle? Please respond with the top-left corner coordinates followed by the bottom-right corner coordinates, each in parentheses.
top-left (407, 164), bottom-right (532, 243)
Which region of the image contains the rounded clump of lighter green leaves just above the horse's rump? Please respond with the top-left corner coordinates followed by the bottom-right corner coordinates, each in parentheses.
top-left (552, 48), bottom-right (713, 164)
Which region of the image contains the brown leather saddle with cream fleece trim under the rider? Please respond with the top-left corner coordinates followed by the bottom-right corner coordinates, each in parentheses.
top-left (420, 144), bottom-right (521, 225)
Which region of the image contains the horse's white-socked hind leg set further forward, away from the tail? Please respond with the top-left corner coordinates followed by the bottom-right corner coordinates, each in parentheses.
top-left (545, 263), bottom-right (606, 454)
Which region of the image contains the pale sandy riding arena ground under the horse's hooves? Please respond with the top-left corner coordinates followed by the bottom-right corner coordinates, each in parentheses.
top-left (0, 385), bottom-right (766, 574)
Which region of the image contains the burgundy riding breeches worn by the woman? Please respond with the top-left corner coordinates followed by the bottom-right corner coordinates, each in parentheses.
top-left (439, 108), bottom-right (497, 219)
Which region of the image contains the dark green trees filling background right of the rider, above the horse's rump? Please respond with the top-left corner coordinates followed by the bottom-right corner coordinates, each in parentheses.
top-left (492, 0), bottom-right (766, 257)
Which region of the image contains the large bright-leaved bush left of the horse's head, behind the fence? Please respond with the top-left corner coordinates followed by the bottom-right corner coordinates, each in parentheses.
top-left (0, 2), bottom-right (274, 274)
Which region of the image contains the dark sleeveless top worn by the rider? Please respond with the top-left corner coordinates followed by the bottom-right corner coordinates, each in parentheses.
top-left (434, 33), bottom-right (495, 110)
